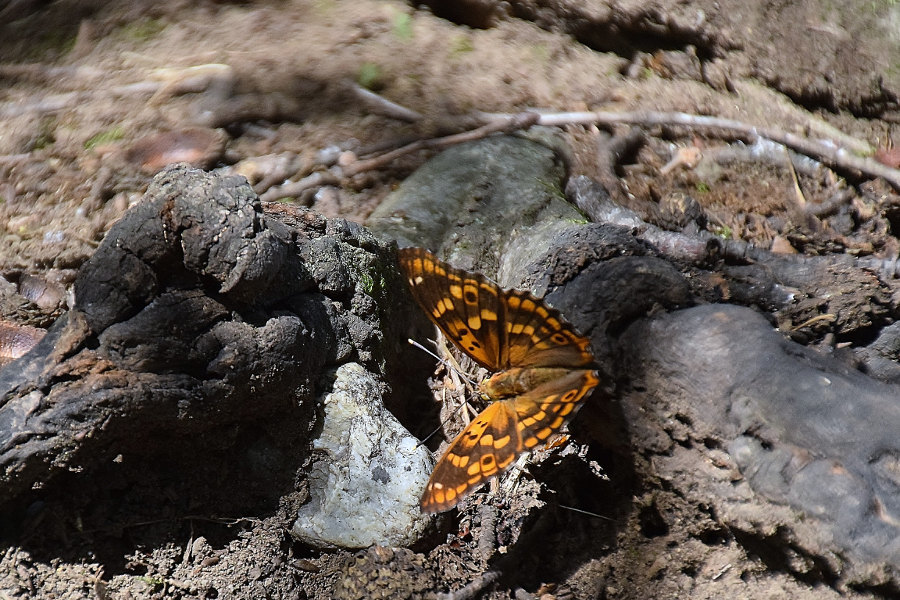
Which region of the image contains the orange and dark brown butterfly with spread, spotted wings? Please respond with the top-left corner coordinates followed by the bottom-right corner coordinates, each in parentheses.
top-left (399, 248), bottom-right (600, 513)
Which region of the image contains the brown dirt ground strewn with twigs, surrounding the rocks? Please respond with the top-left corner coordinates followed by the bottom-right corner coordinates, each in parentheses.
top-left (0, 0), bottom-right (900, 598)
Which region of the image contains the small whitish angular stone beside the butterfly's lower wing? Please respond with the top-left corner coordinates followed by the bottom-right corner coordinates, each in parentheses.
top-left (292, 363), bottom-right (433, 548)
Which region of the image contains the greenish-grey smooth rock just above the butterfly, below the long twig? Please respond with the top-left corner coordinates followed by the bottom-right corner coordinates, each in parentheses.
top-left (368, 135), bottom-right (586, 287)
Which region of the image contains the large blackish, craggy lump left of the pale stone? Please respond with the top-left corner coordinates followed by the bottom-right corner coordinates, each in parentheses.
top-left (0, 166), bottom-right (407, 523)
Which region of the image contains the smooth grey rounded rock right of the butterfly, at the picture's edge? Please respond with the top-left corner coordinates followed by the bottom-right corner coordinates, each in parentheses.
top-left (621, 305), bottom-right (900, 580)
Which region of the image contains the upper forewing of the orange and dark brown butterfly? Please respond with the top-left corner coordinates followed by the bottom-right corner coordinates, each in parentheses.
top-left (399, 248), bottom-right (502, 371)
